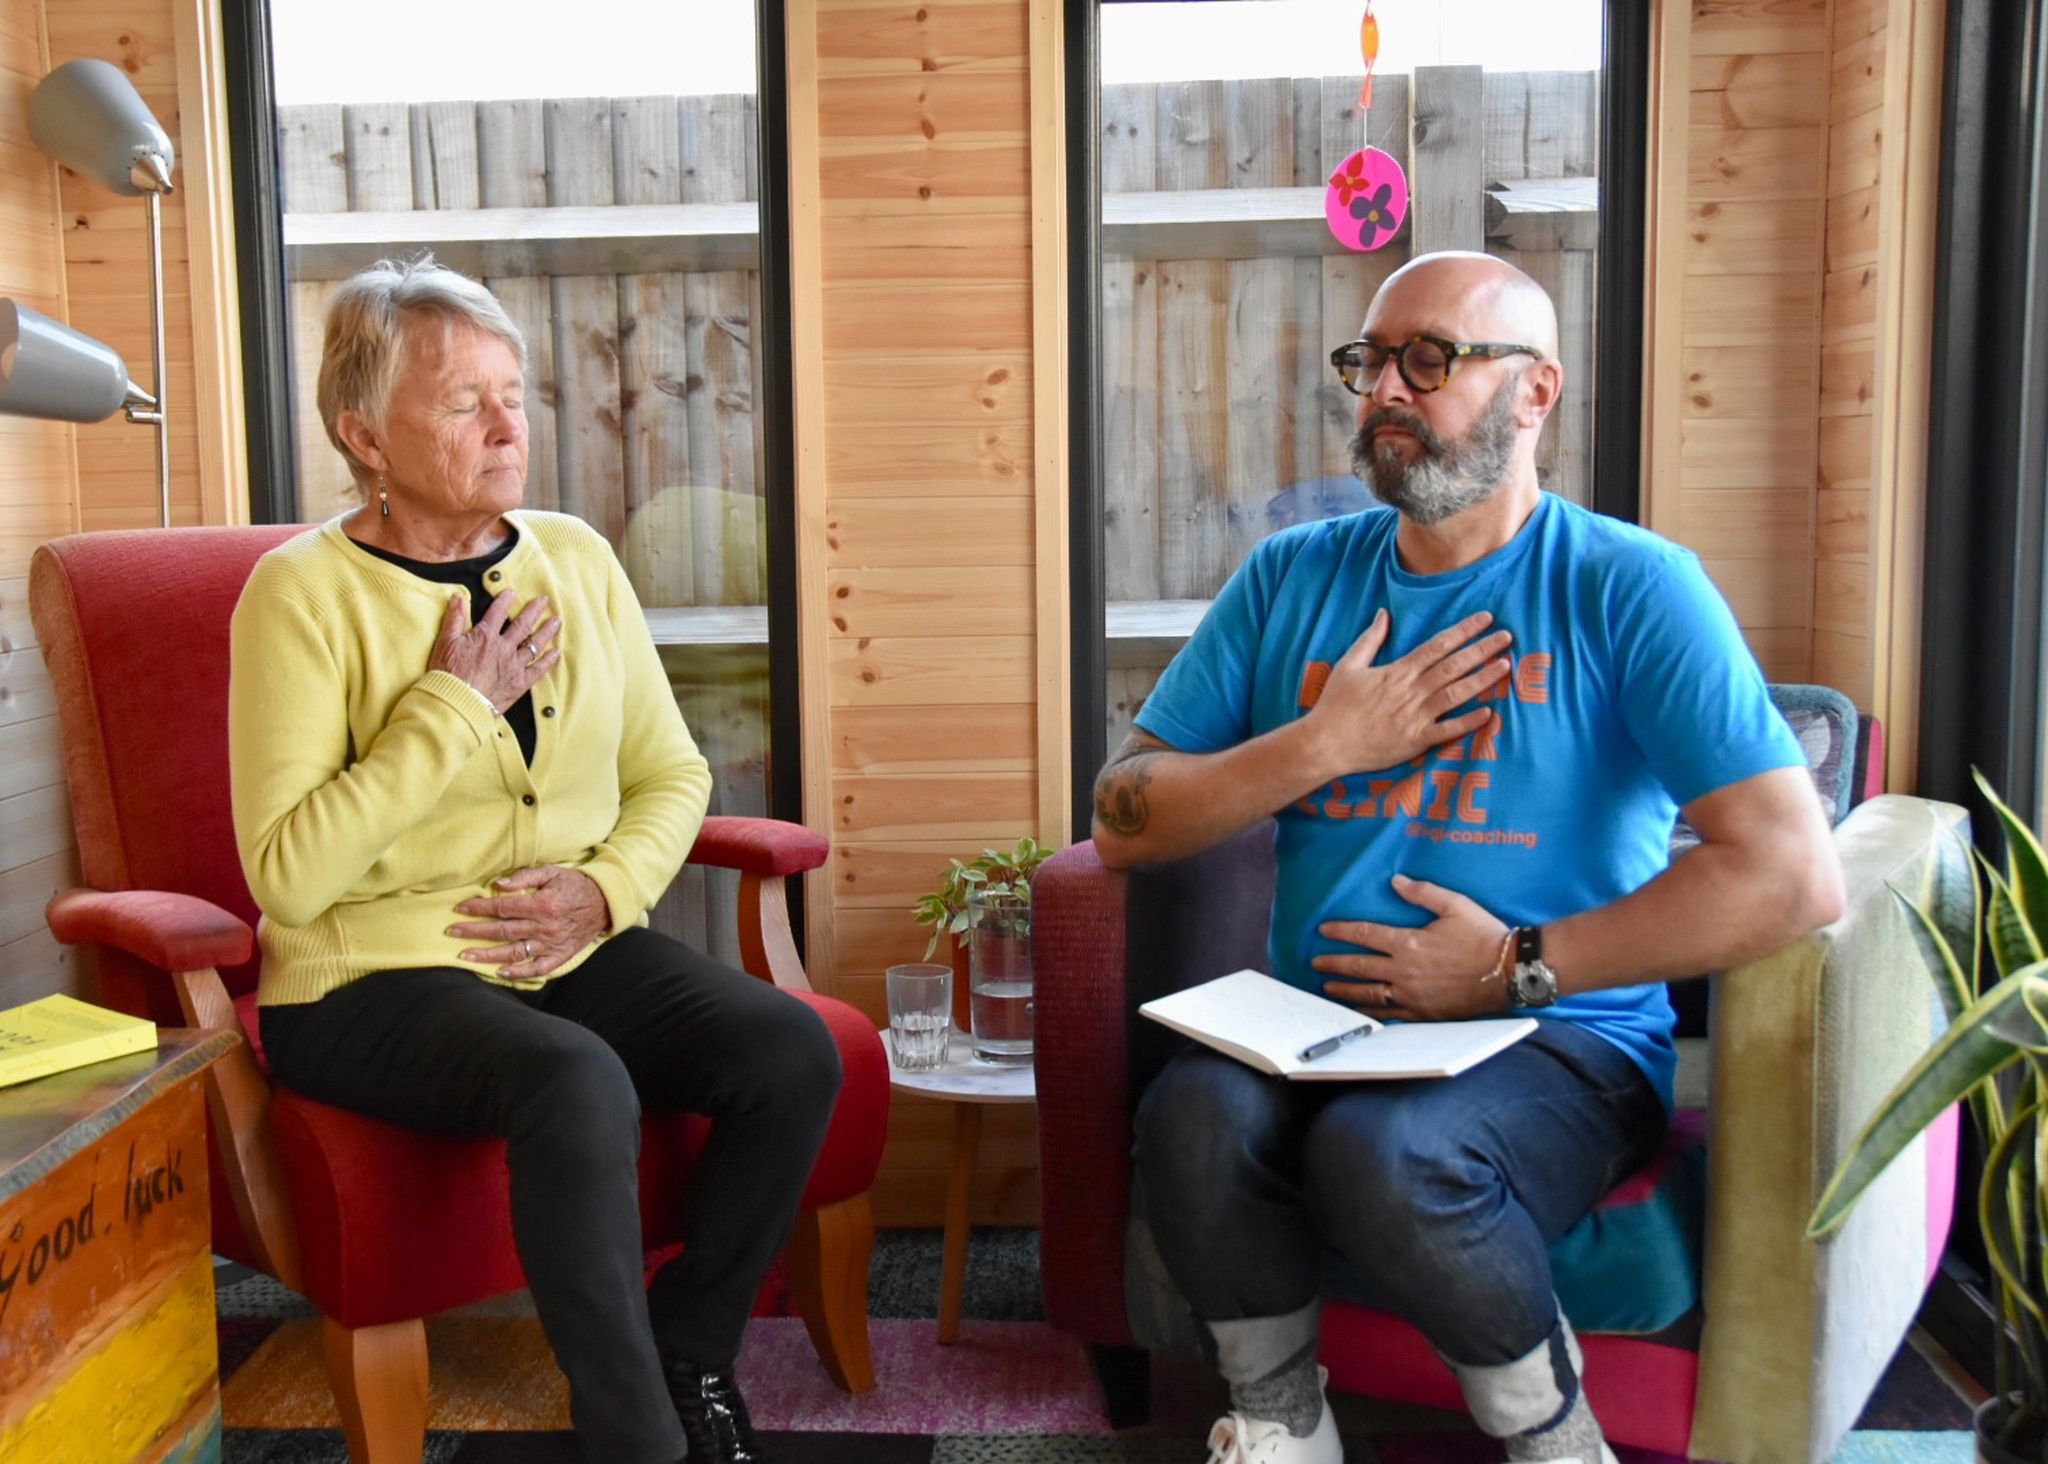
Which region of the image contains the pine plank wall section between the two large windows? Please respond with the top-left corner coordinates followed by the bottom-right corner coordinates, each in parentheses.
top-left (788, 0), bottom-right (1040, 1224)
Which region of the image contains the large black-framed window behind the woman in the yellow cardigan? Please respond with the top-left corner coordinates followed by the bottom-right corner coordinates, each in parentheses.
top-left (249, 0), bottom-right (770, 962)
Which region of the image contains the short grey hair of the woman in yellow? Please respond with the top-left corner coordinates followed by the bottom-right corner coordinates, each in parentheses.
top-left (319, 254), bottom-right (526, 483)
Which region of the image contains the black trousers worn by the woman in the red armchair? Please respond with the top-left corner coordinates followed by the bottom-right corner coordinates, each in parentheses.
top-left (262, 930), bottom-right (840, 1464)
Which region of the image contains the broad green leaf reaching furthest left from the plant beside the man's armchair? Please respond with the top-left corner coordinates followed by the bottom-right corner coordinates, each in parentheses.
top-left (1806, 962), bottom-right (2048, 1237)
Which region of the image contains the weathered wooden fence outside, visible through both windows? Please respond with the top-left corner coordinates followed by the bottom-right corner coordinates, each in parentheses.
top-left (279, 68), bottom-right (1597, 872)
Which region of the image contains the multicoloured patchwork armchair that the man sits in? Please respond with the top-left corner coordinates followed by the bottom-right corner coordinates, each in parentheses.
top-left (1032, 688), bottom-right (1968, 1464)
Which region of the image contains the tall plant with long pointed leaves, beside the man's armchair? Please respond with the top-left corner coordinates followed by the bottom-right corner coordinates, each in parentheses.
top-left (1808, 774), bottom-right (2048, 1464)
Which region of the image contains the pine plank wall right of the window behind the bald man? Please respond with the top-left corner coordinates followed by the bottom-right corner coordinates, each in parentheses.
top-left (1645, 0), bottom-right (1829, 680)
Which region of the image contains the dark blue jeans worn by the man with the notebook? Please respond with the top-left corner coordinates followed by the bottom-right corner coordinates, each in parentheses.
top-left (1137, 1020), bottom-right (1665, 1366)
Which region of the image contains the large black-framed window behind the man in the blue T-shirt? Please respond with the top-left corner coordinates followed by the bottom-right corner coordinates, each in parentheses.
top-left (1075, 0), bottom-right (1634, 776)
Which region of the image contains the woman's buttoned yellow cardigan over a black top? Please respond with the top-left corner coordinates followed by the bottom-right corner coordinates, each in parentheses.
top-left (227, 512), bottom-right (711, 1003)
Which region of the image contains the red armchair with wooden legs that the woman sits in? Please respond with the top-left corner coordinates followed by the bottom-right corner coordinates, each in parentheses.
top-left (29, 528), bottom-right (889, 1464)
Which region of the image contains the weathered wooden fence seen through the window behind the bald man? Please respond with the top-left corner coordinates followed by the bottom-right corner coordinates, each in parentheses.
top-left (1102, 68), bottom-right (1599, 747)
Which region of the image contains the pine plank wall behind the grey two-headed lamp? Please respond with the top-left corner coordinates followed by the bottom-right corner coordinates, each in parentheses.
top-left (0, 0), bottom-right (248, 1003)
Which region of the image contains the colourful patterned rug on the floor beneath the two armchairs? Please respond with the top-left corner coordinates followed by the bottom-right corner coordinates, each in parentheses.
top-left (219, 1231), bottom-right (1972, 1464)
